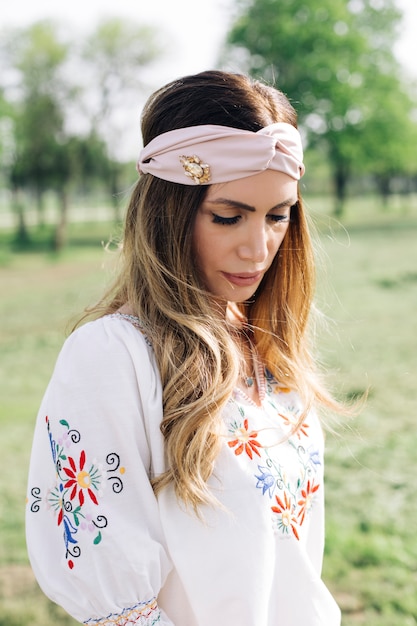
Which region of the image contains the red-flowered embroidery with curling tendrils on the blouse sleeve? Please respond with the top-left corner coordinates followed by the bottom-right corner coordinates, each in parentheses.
top-left (30, 417), bottom-right (125, 569)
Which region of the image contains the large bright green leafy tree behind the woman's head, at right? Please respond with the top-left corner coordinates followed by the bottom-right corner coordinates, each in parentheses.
top-left (225, 0), bottom-right (411, 214)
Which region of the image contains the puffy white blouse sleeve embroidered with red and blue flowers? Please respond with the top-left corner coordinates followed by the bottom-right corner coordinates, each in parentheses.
top-left (26, 317), bottom-right (172, 626)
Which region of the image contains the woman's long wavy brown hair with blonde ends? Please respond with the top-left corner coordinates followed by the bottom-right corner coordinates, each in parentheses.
top-left (82, 71), bottom-right (342, 512)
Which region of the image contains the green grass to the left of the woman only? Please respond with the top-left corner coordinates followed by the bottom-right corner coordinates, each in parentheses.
top-left (0, 224), bottom-right (115, 626)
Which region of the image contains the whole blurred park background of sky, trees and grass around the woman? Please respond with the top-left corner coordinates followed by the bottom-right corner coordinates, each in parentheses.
top-left (0, 0), bottom-right (417, 626)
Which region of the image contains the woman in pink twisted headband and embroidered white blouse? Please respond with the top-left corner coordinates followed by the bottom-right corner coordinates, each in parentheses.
top-left (27, 71), bottom-right (340, 626)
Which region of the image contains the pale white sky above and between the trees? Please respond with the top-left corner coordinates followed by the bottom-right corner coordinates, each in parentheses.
top-left (0, 0), bottom-right (417, 158)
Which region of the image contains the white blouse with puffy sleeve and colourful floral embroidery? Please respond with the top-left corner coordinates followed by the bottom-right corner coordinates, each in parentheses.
top-left (27, 314), bottom-right (340, 626)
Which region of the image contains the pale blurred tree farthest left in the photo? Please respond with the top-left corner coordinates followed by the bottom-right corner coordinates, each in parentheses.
top-left (3, 21), bottom-right (68, 243)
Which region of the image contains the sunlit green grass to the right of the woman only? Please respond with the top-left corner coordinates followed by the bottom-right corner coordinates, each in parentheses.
top-left (310, 197), bottom-right (417, 626)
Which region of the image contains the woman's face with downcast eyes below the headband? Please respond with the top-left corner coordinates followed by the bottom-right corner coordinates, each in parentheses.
top-left (193, 170), bottom-right (297, 302)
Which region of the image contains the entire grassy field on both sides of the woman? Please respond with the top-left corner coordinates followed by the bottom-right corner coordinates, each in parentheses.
top-left (0, 199), bottom-right (417, 626)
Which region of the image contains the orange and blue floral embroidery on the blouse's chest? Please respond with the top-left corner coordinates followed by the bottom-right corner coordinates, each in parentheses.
top-left (227, 372), bottom-right (322, 540)
